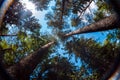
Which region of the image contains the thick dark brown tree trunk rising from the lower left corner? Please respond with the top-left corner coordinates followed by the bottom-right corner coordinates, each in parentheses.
top-left (7, 42), bottom-right (54, 80)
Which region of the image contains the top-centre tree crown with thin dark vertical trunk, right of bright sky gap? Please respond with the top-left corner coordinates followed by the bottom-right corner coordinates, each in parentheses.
top-left (46, 0), bottom-right (92, 30)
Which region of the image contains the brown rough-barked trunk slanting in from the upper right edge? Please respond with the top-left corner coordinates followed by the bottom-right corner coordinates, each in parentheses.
top-left (64, 14), bottom-right (120, 37)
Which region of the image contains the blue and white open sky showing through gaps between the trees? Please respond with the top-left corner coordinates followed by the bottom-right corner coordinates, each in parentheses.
top-left (22, 0), bottom-right (107, 66)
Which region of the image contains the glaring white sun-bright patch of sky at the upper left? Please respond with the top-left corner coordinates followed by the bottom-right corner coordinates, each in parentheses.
top-left (21, 0), bottom-right (35, 13)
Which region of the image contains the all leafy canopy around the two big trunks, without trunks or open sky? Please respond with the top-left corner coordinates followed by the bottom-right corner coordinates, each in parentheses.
top-left (0, 0), bottom-right (120, 80)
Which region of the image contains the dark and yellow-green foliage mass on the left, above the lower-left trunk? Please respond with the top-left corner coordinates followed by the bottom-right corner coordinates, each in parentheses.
top-left (0, 1), bottom-right (50, 67)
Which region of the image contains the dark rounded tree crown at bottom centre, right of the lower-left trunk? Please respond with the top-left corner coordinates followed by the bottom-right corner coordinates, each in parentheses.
top-left (38, 56), bottom-right (75, 80)
